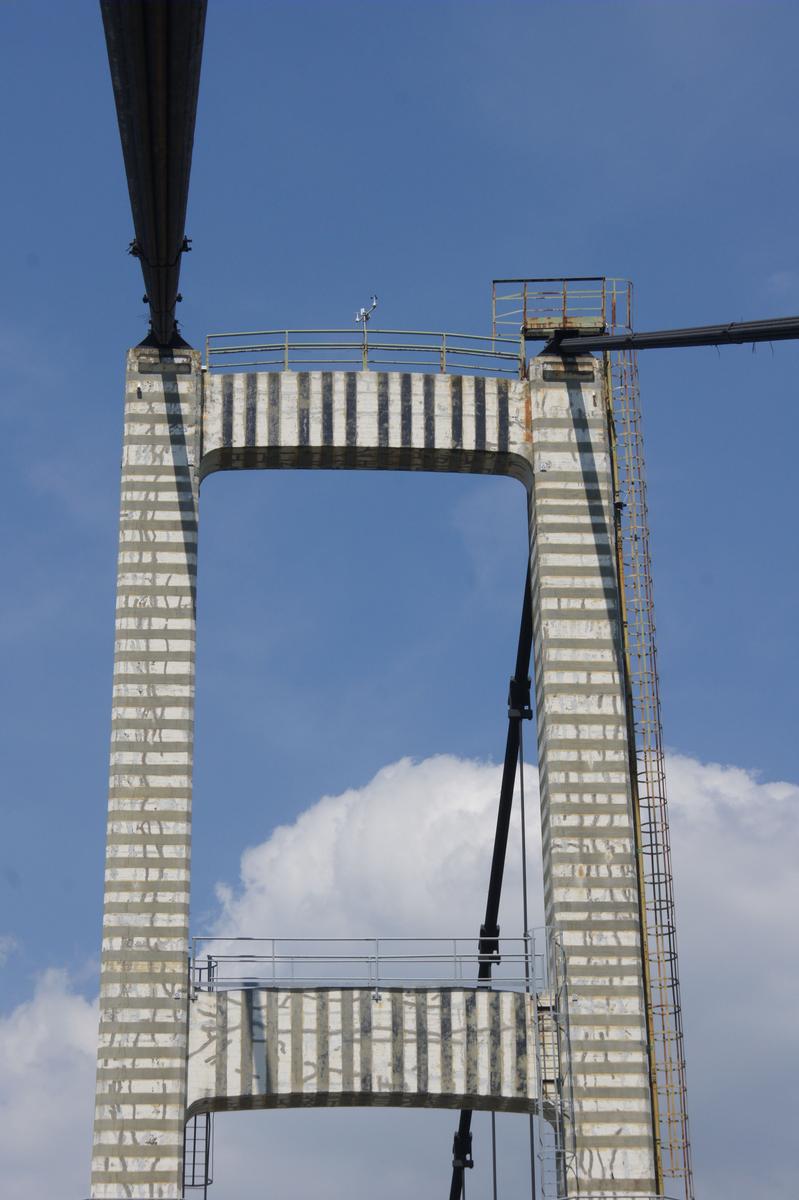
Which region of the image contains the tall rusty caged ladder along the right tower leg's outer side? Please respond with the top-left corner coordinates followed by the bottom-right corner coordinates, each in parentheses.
top-left (605, 314), bottom-right (693, 1200)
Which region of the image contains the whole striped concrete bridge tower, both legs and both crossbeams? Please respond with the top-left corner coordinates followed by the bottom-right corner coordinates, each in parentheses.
top-left (91, 285), bottom-right (686, 1200)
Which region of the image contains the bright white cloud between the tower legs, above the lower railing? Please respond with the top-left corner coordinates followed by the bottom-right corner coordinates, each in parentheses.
top-left (214, 755), bottom-right (542, 937)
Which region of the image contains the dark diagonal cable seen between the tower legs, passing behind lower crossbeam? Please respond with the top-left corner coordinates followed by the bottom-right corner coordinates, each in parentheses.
top-left (450, 566), bottom-right (533, 1200)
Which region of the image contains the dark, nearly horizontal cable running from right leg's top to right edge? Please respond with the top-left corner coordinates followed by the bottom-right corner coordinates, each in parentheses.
top-left (535, 317), bottom-right (799, 354)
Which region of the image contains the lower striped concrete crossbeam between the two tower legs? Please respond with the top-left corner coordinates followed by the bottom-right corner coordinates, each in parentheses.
top-left (188, 988), bottom-right (537, 1112)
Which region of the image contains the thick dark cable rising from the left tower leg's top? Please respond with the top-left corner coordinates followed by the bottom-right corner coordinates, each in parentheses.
top-left (100, 0), bottom-right (206, 346)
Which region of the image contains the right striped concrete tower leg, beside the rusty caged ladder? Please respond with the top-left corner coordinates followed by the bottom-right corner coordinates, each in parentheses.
top-left (530, 358), bottom-right (656, 1196)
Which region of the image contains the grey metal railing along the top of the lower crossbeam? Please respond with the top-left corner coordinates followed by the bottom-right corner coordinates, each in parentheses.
top-left (191, 930), bottom-right (565, 1006)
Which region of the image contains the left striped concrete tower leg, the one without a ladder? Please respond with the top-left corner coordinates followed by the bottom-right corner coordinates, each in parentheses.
top-left (91, 347), bottom-right (202, 1200)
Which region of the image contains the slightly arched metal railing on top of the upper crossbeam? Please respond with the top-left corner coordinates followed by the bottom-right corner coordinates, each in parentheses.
top-left (205, 325), bottom-right (525, 378)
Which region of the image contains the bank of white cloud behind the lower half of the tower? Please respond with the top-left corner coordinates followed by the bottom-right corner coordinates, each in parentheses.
top-left (0, 755), bottom-right (799, 1200)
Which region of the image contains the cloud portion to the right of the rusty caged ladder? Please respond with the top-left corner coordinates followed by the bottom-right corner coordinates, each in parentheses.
top-left (668, 755), bottom-right (799, 1200)
